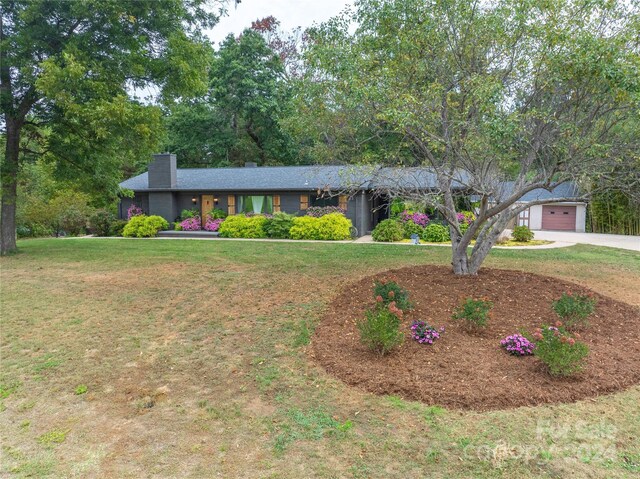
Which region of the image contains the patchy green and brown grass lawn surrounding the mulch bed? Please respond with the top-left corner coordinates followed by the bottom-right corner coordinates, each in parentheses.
top-left (0, 239), bottom-right (640, 478)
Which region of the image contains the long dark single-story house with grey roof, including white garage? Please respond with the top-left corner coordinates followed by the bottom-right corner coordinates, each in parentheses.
top-left (119, 153), bottom-right (586, 236)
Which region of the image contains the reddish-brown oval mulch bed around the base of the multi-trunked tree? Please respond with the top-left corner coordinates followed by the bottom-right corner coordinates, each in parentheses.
top-left (312, 265), bottom-right (640, 411)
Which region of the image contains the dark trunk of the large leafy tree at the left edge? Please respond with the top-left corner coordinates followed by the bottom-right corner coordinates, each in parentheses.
top-left (0, 117), bottom-right (20, 255)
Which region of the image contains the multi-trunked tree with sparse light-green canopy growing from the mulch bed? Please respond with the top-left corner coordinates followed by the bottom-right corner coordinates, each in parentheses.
top-left (306, 0), bottom-right (640, 274)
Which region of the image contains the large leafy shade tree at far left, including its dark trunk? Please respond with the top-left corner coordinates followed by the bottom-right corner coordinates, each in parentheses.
top-left (0, 0), bottom-right (228, 254)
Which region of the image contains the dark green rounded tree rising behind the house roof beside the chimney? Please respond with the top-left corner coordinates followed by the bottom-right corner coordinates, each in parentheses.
top-left (167, 29), bottom-right (297, 166)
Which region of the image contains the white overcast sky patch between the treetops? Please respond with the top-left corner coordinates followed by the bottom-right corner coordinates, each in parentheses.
top-left (208, 0), bottom-right (351, 46)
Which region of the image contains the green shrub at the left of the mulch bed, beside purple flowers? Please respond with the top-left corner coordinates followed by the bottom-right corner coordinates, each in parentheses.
top-left (358, 305), bottom-right (404, 355)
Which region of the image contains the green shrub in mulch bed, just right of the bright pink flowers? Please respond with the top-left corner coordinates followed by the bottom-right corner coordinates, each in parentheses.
top-left (533, 326), bottom-right (589, 376)
